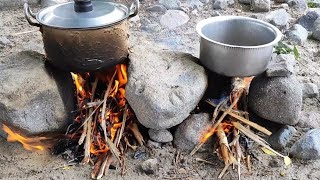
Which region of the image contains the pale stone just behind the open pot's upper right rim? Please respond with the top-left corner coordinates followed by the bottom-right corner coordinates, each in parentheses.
top-left (266, 9), bottom-right (290, 29)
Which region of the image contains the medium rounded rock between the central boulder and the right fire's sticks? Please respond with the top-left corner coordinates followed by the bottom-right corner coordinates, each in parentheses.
top-left (173, 113), bottom-right (211, 151)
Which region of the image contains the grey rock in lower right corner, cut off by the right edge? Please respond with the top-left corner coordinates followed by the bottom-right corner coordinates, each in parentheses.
top-left (290, 128), bottom-right (320, 160)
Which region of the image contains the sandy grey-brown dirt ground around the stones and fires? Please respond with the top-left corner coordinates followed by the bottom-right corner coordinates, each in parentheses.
top-left (0, 1), bottom-right (320, 180)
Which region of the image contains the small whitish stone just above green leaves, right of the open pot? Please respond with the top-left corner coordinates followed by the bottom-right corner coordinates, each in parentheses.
top-left (286, 24), bottom-right (308, 45)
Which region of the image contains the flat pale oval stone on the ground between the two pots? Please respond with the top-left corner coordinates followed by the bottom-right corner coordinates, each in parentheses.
top-left (160, 10), bottom-right (190, 29)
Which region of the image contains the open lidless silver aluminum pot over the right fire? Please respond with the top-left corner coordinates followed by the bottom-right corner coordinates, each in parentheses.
top-left (196, 16), bottom-right (282, 77)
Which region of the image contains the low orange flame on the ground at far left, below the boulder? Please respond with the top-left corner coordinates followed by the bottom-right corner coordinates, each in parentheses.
top-left (2, 124), bottom-right (48, 151)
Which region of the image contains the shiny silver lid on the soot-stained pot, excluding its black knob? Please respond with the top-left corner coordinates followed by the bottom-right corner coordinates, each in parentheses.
top-left (36, 1), bottom-right (129, 29)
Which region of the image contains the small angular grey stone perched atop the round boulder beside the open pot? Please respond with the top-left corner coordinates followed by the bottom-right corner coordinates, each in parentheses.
top-left (266, 54), bottom-right (296, 77)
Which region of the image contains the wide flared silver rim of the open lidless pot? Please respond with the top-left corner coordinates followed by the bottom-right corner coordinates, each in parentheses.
top-left (196, 16), bottom-right (283, 49)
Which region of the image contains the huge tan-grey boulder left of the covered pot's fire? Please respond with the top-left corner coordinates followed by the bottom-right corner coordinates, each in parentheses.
top-left (0, 52), bottom-right (74, 138)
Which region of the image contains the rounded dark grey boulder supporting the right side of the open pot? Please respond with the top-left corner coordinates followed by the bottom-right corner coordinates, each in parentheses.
top-left (249, 75), bottom-right (302, 125)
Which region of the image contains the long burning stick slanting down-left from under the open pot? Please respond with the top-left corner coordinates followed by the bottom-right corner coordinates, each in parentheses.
top-left (190, 89), bottom-right (244, 156)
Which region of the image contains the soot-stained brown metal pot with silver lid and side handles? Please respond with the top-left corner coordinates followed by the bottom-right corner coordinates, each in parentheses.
top-left (24, 0), bottom-right (139, 72)
